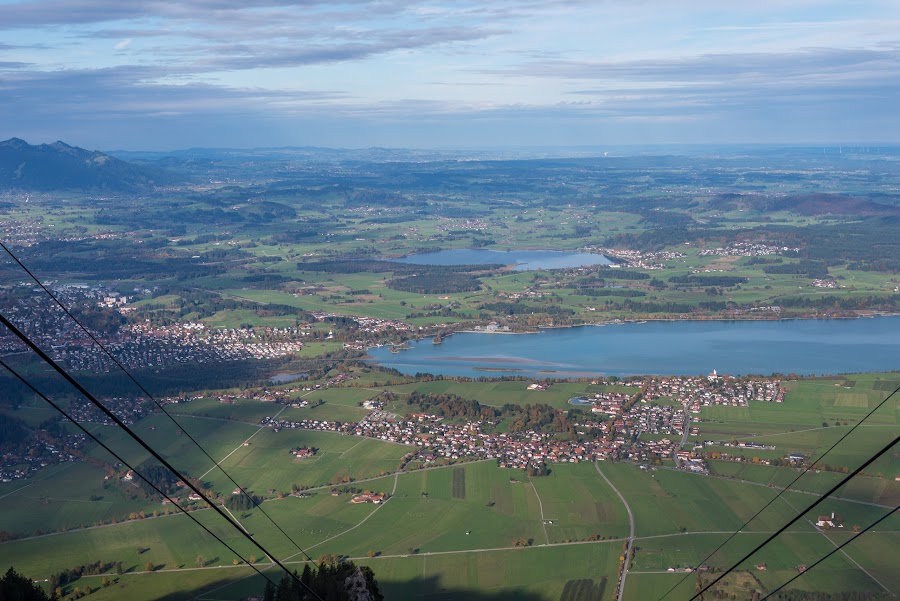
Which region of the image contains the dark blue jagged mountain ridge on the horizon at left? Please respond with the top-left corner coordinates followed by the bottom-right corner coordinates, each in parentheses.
top-left (0, 138), bottom-right (176, 192)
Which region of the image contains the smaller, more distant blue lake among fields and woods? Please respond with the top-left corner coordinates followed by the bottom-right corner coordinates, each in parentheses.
top-left (394, 248), bottom-right (612, 271)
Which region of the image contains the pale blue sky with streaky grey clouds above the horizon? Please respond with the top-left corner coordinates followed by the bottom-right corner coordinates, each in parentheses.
top-left (0, 0), bottom-right (900, 150)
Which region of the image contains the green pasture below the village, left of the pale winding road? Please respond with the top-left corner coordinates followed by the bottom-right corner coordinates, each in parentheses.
top-left (292, 462), bottom-right (627, 555)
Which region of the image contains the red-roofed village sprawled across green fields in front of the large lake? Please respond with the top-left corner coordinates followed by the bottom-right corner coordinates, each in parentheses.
top-left (260, 373), bottom-right (784, 473)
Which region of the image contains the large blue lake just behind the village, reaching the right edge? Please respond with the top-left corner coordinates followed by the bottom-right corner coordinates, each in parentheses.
top-left (369, 317), bottom-right (900, 377)
